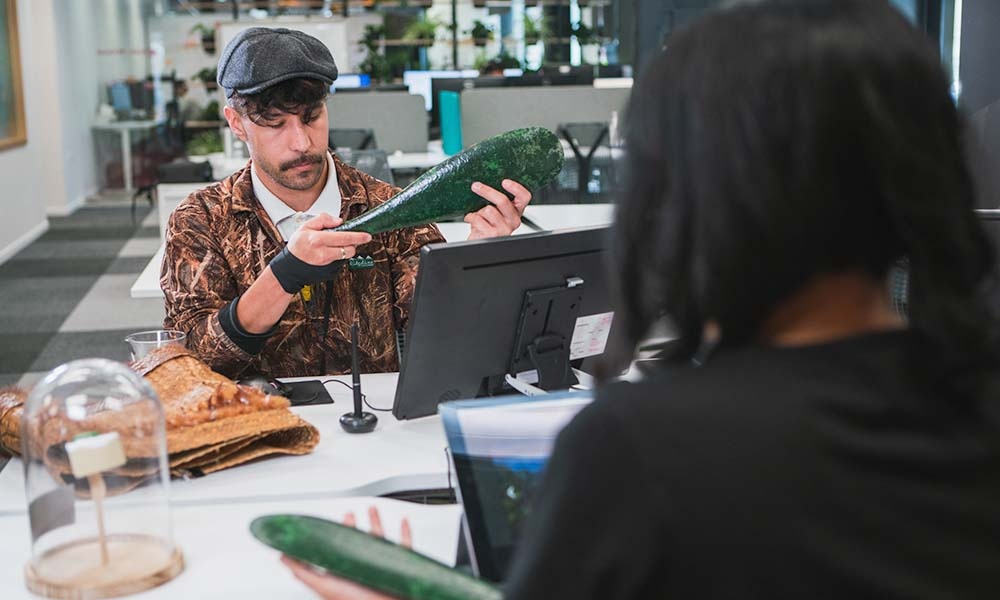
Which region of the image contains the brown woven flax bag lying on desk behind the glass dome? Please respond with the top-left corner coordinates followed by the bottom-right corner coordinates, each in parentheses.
top-left (0, 346), bottom-right (319, 494)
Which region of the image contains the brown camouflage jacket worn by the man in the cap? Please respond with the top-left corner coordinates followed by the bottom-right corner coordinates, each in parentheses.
top-left (160, 152), bottom-right (444, 378)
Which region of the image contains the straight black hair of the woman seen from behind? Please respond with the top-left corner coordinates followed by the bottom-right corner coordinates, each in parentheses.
top-left (613, 0), bottom-right (997, 394)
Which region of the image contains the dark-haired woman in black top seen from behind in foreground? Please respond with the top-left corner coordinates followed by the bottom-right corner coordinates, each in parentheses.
top-left (284, 0), bottom-right (1000, 598)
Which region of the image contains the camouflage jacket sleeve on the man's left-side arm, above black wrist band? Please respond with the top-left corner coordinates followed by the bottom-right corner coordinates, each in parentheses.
top-left (160, 195), bottom-right (253, 378)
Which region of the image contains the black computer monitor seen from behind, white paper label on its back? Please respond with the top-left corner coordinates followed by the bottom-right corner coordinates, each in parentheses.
top-left (393, 227), bottom-right (627, 419)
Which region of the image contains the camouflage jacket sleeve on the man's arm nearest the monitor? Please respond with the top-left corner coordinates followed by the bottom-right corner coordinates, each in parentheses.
top-left (370, 181), bottom-right (445, 329)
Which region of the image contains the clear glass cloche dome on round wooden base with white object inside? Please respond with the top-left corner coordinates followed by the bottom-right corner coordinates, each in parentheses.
top-left (22, 359), bottom-right (184, 598)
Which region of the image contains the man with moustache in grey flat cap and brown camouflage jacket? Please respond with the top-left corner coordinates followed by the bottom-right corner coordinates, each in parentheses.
top-left (160, 27), bottom-right (531, 378)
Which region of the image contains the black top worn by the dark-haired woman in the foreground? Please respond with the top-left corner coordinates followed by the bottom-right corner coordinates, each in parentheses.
top-left (507, 332), bottom-right (1000, 600)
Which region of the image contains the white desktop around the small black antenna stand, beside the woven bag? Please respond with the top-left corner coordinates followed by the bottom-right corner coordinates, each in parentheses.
top-left (0, 373), bottom-right (448, 512)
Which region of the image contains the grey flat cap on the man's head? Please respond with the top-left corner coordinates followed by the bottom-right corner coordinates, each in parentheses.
top-left (216, 27), bottom-right (337, 98)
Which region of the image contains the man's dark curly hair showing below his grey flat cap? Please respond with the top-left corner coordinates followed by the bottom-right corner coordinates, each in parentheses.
top-left (229, 78), bottom-right (330, 125)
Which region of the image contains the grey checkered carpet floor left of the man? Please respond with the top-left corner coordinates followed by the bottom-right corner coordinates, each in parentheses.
top-left (0, 202), bottom-right (163, 388)
